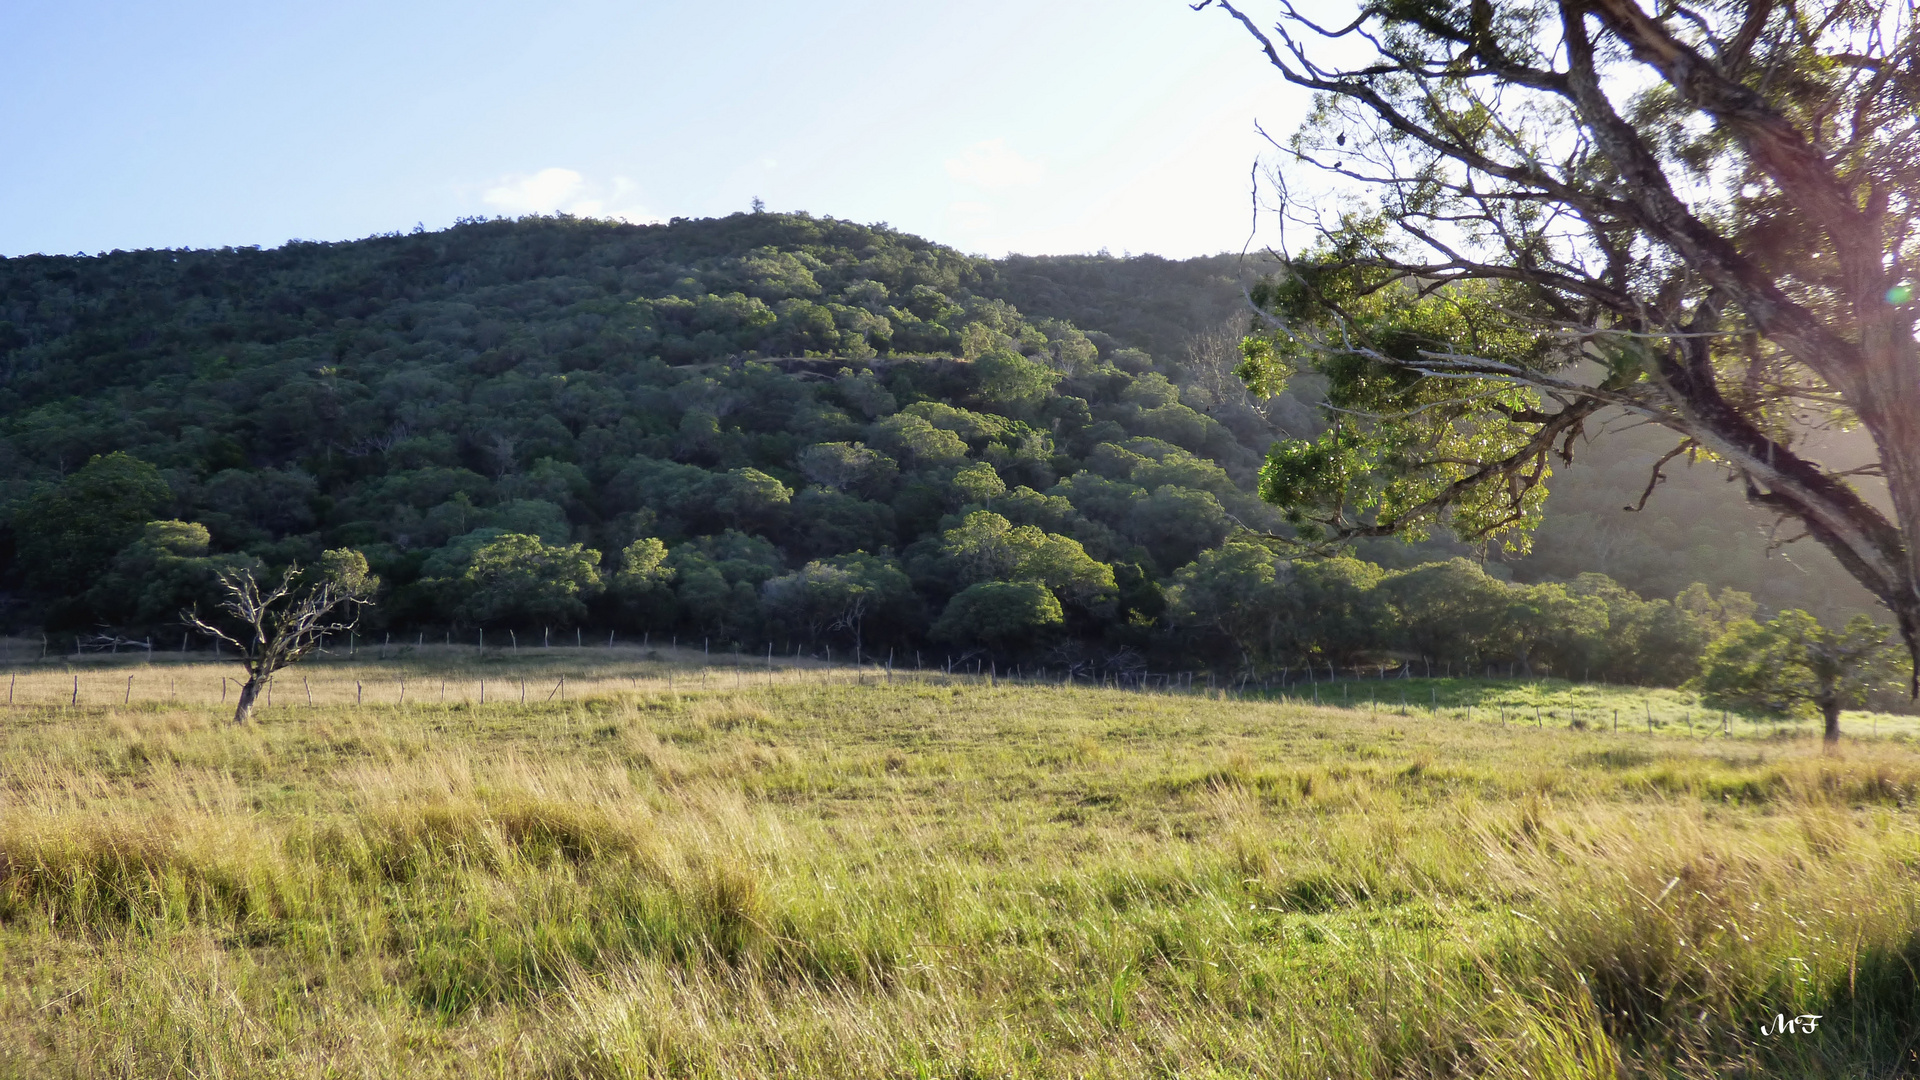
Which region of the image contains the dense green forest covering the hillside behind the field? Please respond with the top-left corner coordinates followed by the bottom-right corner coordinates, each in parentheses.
top-left (0, 213), bottom-right (1864, 682)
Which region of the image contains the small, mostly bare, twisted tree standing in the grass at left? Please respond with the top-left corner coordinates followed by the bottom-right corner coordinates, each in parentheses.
top-left (184, 548), bottom-right (380, 724)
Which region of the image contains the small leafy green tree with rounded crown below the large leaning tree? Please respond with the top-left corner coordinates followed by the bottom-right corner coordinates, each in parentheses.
top-left (1697, 611), bottom-right (1897, 744)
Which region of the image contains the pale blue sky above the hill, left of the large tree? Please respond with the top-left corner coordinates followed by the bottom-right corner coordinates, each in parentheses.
top-left (0, 0), bottom-right (1308, 258)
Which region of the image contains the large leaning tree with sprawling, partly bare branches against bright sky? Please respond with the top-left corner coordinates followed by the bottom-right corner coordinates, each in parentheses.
top-left (1198, 0), bottom-right (1920, 672)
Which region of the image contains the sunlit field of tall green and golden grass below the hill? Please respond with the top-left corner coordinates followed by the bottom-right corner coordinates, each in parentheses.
top-left (0, 648), bottom-right (1920, 1078)
